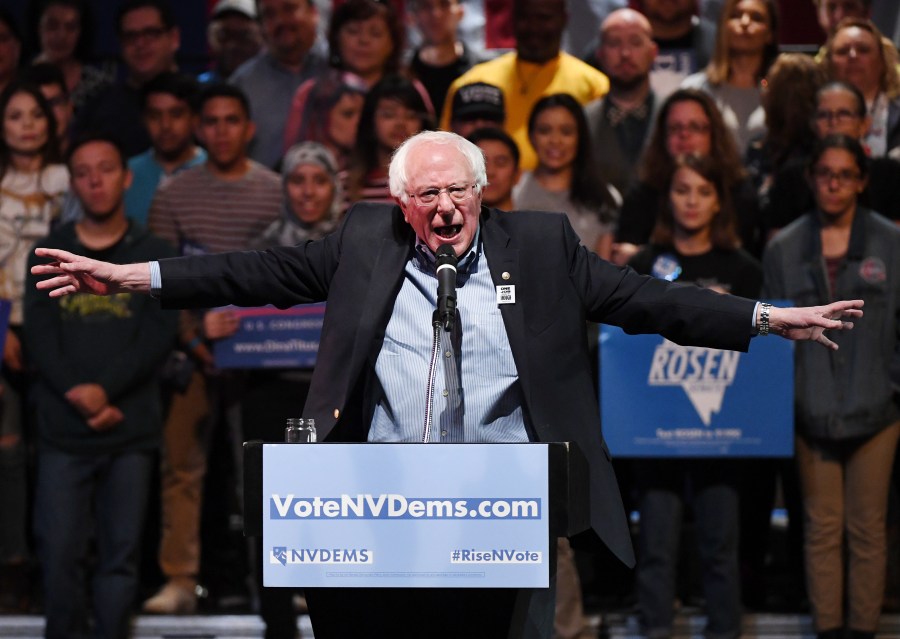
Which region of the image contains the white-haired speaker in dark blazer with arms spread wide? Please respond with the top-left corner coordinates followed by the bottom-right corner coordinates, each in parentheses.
top-left (32, 131), bottom-right (862, 639)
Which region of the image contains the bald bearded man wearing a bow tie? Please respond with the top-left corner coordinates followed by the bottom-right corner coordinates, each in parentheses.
top-left (584, 9), bottom-right (660, 193)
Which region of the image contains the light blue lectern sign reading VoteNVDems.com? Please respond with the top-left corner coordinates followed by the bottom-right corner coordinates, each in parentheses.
top-left (262, 444), bottom-right (549, 588)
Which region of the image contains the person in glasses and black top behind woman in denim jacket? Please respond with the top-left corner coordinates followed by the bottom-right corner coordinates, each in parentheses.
top-left (763, 81), bottom-right (900, 237)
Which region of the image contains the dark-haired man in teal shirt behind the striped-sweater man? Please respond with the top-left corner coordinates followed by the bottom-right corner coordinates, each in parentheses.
top-left (125, 73), bottom-right (206, 224)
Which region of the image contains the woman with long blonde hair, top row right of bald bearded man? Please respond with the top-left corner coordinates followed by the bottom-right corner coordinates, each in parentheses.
top-left (682, 0), bottom-right (778, 154)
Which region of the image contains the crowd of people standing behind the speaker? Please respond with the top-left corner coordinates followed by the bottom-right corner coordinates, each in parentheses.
top-left (0, 0), bottom-right (900, 639)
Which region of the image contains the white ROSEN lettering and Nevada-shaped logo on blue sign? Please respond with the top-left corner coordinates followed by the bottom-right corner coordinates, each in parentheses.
top-left (647, 340), bottom-right (741, 426)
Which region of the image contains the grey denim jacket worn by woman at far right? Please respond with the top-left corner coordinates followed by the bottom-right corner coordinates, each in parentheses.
top-left (763, 207), bottom-right (900, 440)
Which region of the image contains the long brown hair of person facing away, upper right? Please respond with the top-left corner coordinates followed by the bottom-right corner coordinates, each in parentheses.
top-left (762, 53), bottom-right (828, 168)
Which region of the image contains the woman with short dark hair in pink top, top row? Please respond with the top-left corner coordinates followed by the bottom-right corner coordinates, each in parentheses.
top-left (284, 0), bottom-right (404, 159)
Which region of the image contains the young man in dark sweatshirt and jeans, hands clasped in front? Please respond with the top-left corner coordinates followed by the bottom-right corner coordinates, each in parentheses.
top-left (24, 136), bottom-right (177, 639)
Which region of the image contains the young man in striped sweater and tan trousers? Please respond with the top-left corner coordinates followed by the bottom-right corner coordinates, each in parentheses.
top-left (144, 84), bottom-right (282, 614)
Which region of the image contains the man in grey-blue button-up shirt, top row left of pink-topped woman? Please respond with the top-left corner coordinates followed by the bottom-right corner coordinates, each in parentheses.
top-left (228, 0), bottom-right (326, 168)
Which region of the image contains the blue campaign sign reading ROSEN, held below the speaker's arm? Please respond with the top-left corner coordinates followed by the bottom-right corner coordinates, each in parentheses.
top-left (600, 326), bottom-right (794, 457)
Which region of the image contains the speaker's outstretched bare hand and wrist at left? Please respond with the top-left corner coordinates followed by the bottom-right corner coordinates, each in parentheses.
top-left (31, 248), bottom-right (150, 297)
